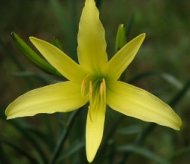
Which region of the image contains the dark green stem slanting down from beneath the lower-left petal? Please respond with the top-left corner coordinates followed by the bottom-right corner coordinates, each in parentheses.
top-left (50, 110), bottom-right (81, 164)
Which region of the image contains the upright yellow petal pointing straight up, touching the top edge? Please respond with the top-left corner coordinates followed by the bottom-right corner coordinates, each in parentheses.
top-left (78, 0), bottom-right (107, 71)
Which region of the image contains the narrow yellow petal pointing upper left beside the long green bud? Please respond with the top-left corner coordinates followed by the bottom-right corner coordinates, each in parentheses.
top-left (30, 37), bottom-right (85, 81)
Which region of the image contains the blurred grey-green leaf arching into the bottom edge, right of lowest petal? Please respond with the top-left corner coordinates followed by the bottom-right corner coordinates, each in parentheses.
top-left (117, 145), bottom-right (169, 164)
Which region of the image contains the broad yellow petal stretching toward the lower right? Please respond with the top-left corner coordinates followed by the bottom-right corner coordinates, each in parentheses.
top-left (107, 82), bottom-right (182, 130)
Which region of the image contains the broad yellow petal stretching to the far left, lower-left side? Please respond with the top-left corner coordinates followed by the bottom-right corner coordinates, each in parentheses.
top-left (5, 82), bottom-right (86, 119)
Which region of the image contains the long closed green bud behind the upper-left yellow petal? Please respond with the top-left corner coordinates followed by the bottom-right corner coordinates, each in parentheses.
top-left (11, 32), bottom-right (61, 76)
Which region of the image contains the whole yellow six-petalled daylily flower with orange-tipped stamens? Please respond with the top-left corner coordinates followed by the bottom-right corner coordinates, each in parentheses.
top-left (6, 0), bottom-right (182, 162)
